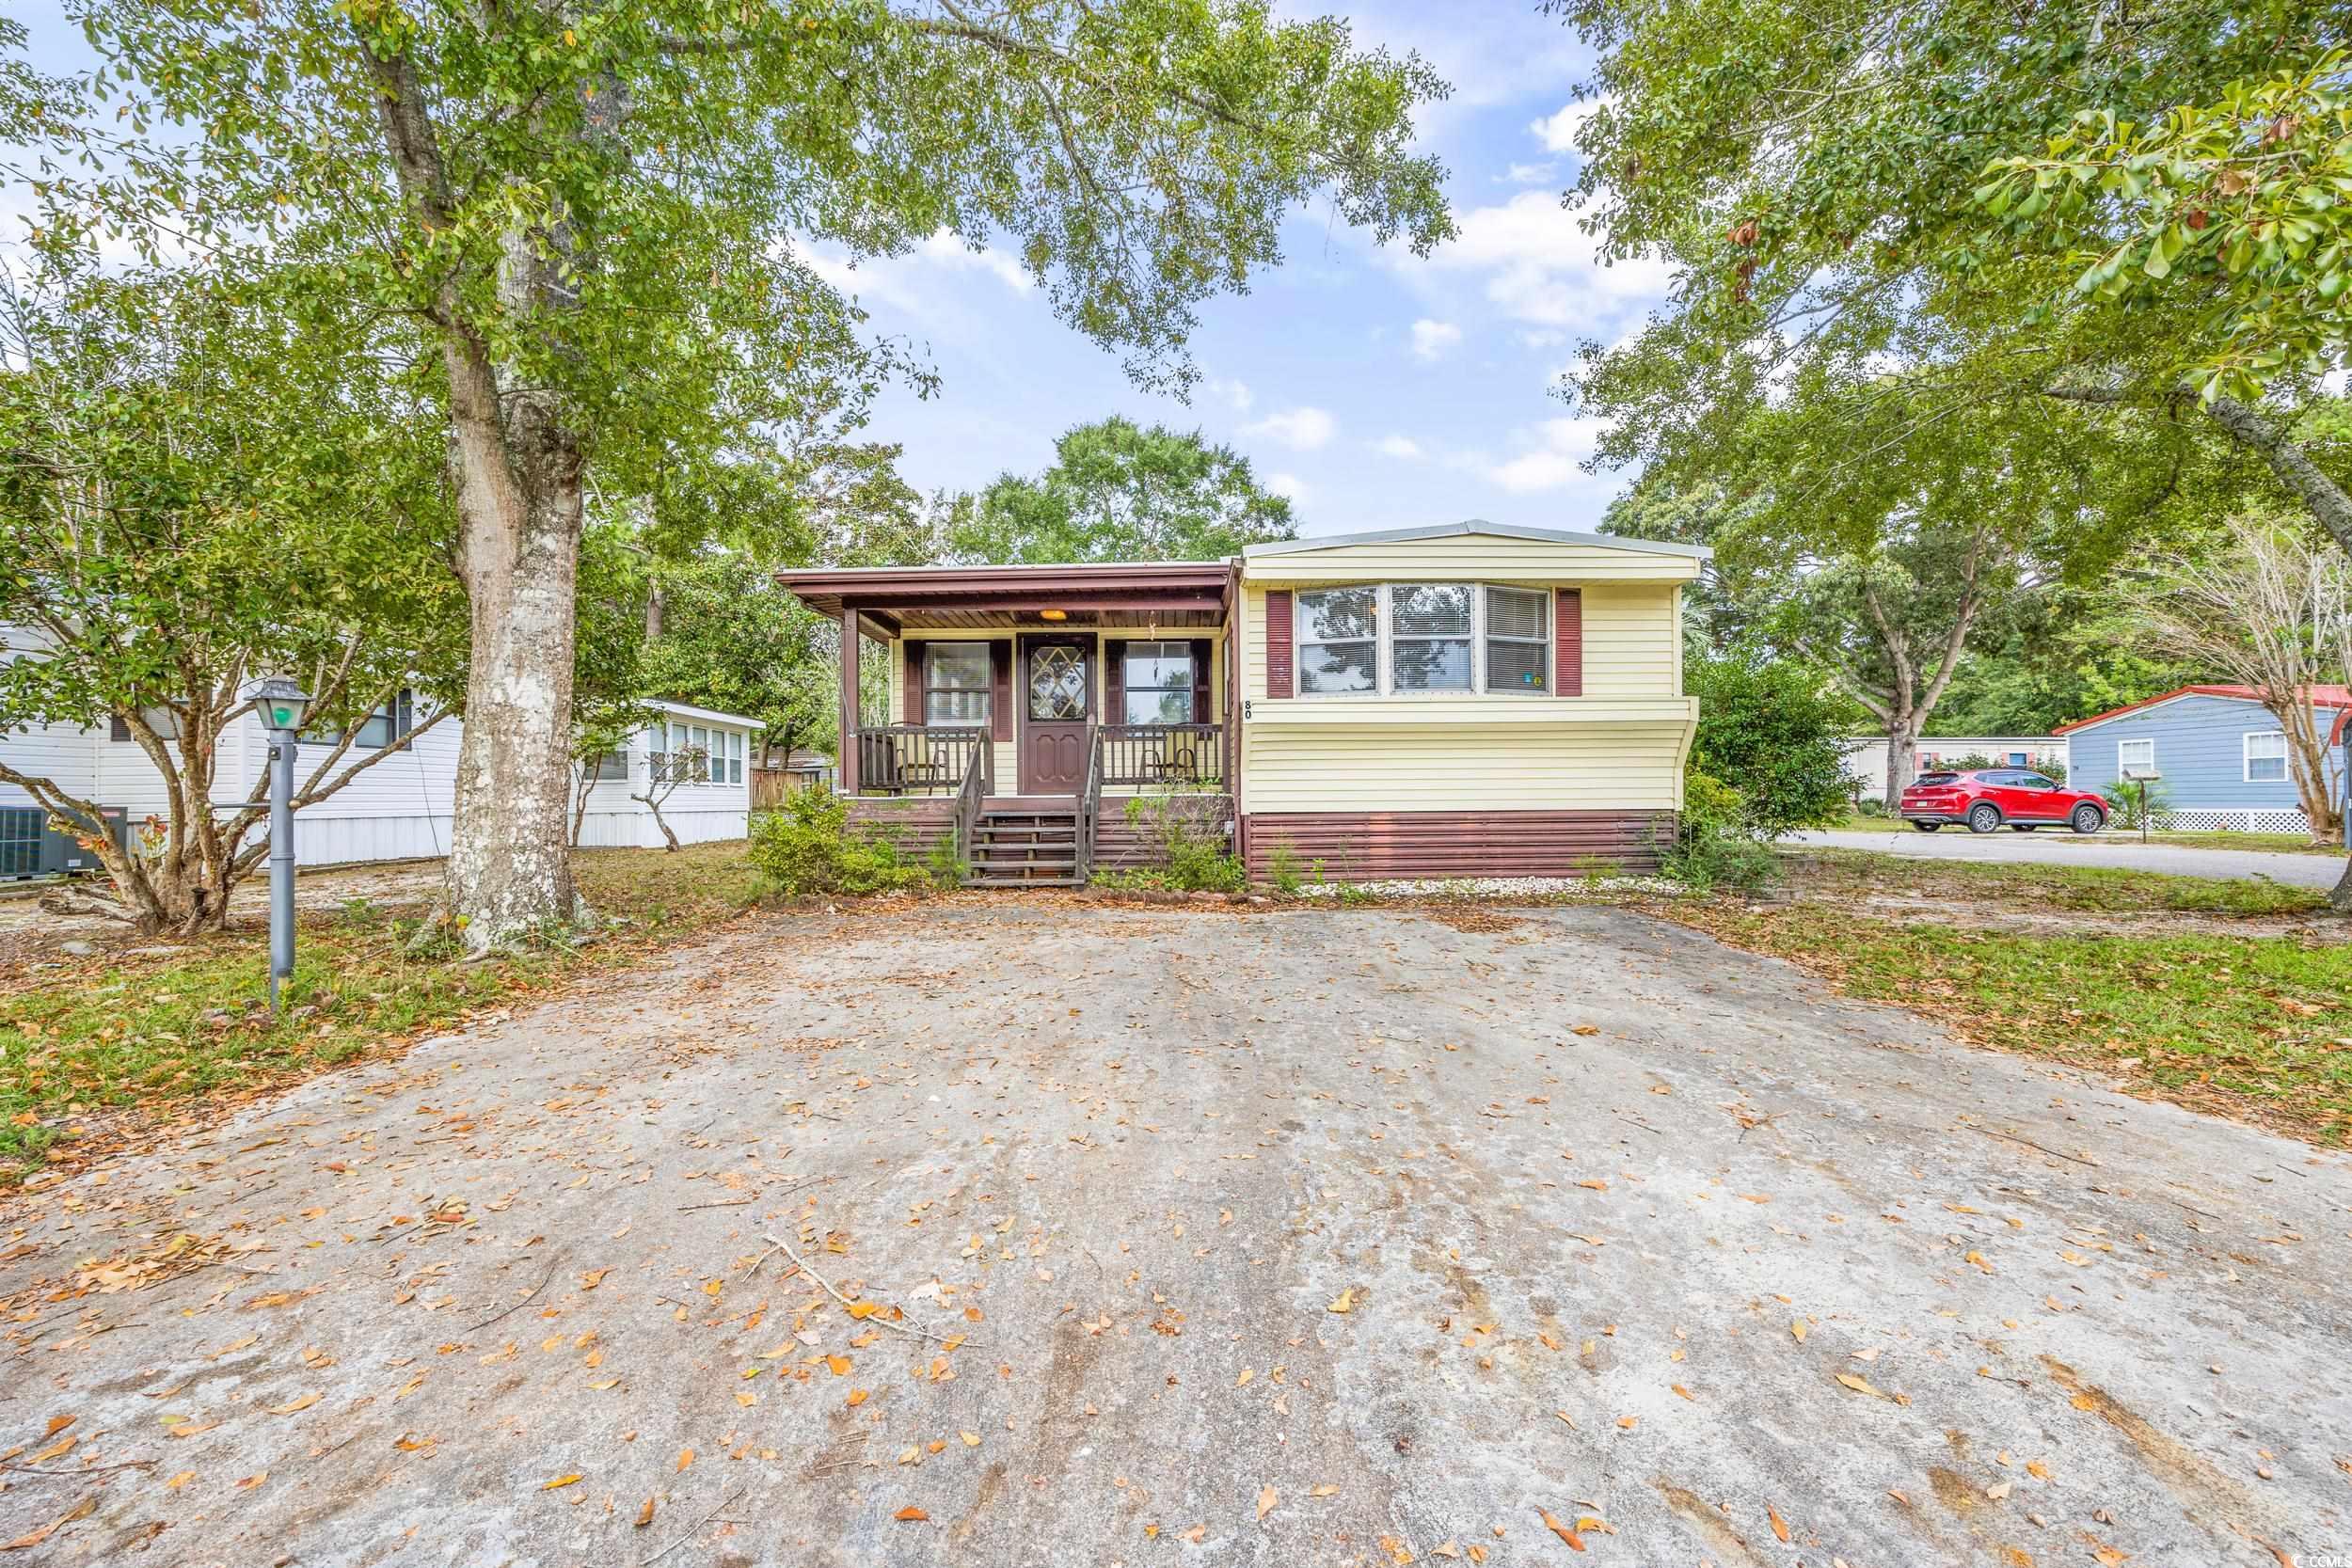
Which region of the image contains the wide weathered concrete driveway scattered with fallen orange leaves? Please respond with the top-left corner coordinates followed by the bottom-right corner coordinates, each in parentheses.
top-left (0, 903), bottom-right (2352, 1568)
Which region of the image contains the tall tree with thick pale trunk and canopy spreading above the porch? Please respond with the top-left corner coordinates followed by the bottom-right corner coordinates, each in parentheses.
top-left (45, 0), bottom-right (1452, 950)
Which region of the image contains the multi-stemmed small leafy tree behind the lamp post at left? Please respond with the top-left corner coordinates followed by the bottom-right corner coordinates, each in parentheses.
top-left (0, 270), bottom-right (464, 936)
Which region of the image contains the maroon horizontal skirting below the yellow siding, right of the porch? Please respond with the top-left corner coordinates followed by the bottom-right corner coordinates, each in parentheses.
top-left (1242, 811), bottom-right (1675, 881)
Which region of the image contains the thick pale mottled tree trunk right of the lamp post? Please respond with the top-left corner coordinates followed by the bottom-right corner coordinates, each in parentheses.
top-left (447, 339), bottom-right (581, 952)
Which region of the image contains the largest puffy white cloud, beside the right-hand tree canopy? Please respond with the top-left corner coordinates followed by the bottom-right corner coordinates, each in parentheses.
top-left (1405, 190), bottom-right (1675, 326)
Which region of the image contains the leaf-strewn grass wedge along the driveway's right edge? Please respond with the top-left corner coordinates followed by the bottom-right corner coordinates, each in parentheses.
top-left (1679, 905), bottom-right (2352, 1145)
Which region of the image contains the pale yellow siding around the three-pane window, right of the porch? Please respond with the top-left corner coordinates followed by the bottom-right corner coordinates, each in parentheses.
top-left (1237, 536), bottom-right (1701, 814)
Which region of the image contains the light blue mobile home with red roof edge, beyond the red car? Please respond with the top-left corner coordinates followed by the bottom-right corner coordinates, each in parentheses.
top-left (2054, 687), bottom-right (2352, 832)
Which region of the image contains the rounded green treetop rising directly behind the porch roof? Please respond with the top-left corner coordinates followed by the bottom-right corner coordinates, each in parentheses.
top-left (948, 416), bottom-right (1298, 566)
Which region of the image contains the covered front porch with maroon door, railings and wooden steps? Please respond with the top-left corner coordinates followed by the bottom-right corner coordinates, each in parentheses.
top-left (781, 562), bottom-right (1237, 884)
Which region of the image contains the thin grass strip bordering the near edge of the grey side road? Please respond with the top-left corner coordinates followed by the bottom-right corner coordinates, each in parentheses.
top-left (1783, 848), bottom-right (2328, 917)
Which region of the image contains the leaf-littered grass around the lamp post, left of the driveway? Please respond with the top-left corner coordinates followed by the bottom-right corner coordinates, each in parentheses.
top-left (0, 844), bottom-right (753, 1180)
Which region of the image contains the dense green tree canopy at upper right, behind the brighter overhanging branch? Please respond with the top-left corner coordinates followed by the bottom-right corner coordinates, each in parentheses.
top-left (1548, 0), bottom-right (2352, 573)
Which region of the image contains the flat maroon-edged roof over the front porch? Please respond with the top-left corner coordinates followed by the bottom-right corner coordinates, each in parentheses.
top-left (776, 562), bottom-right (1232, 637)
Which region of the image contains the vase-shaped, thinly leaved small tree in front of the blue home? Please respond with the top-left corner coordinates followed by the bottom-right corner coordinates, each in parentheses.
top-left (2138, 513), bottom-right (2352, 844)
